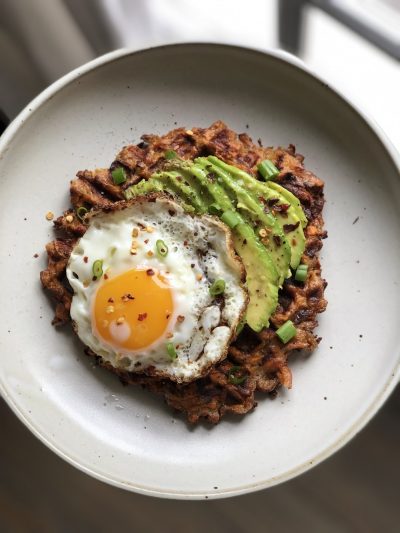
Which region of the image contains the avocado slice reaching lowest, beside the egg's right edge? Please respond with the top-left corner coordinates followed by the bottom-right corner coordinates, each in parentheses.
top-left (180, 160), bottom-right (279, 331)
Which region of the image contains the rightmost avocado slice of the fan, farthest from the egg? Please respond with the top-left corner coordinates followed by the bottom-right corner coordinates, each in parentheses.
top-left (207, 156), bottom-right (305, 268)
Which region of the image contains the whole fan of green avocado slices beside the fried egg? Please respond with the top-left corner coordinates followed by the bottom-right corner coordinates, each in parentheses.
top-left (125, 156), bottom-right (306, 331)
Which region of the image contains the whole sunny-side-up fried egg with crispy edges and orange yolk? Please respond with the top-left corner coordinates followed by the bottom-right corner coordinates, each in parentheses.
top-left (67, 196), bottom-right (248, 382)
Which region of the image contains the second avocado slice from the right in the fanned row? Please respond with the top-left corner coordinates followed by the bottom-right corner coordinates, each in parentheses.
top-left (195, 157), bottom-right (291, 286)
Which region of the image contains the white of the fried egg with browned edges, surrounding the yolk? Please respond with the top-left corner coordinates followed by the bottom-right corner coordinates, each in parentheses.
top-left (67, 197), bottom-right (247, 382)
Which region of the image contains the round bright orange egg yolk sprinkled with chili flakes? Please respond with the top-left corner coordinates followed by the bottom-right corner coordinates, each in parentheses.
top-left (92, 269), bottom-right (173, 351)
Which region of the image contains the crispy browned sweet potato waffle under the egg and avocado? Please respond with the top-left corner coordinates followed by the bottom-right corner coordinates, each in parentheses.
top-left (41, 121), bottom-right (327, 424)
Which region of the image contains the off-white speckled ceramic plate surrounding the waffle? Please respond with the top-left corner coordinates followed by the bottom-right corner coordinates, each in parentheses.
top-left (0, 44), bottom-right (400, 498)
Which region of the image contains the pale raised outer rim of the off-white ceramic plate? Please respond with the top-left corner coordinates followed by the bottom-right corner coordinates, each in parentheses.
top-left (0, 41), bottom-right (400, 500)
